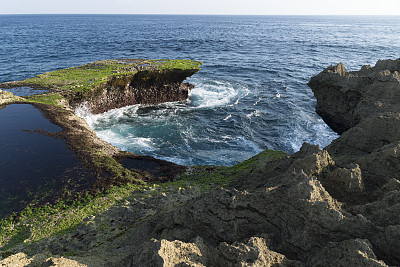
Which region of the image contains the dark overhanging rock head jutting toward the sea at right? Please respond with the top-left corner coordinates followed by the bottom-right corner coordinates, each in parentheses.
top-left (308, 59), bottom-right (400, 134)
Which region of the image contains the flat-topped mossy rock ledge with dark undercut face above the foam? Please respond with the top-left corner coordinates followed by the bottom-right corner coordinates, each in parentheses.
top-left (0, 59), bottom-right (202, 114)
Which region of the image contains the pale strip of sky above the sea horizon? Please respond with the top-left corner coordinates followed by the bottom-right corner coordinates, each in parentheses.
top-left (0, 0), bottom-right (400, 15)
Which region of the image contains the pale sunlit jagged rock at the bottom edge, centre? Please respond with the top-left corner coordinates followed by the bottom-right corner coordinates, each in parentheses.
top-left (123, 237), bottom-right (301, 267)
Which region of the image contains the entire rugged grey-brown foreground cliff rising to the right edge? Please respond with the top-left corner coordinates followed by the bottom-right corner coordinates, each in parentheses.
top-left (0, 59), bottom-right (400, 266)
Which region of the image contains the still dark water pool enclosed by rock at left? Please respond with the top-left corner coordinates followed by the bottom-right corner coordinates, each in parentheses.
top-left (0, 104), bottom-right (92, 217)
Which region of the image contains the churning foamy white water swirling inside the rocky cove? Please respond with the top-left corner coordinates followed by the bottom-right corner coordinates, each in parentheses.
top-left (72, 75), bottom-right (338, 165)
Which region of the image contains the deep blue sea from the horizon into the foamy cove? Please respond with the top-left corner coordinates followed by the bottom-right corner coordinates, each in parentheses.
top-left (0, 15), bottom-right (400, 165)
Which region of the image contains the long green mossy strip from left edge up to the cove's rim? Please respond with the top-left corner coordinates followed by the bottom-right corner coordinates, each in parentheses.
top-left (0, 150), bottom-right (287, 255)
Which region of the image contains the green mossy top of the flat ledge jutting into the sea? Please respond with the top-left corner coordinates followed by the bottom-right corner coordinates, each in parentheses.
top-left (0, 59), bottom-right (202, 110)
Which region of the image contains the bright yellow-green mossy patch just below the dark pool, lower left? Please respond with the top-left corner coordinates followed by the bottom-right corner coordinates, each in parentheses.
top-left (0, 184), bottom-right (145, 251)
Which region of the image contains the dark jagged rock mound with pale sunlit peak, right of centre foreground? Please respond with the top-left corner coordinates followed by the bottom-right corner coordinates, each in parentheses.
top-left (149, 152), bottom-right (376, 260)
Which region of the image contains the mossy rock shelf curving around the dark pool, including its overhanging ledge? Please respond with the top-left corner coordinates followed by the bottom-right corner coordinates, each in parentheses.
top-left (0, 59), bottom-right (202, 218)
